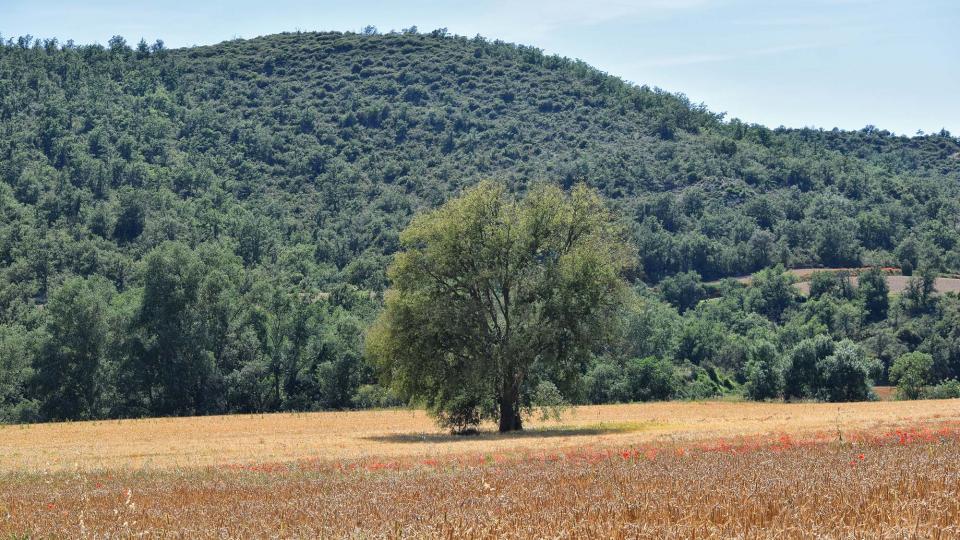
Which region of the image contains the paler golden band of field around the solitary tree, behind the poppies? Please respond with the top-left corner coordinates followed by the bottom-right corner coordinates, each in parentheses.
top-left (0, 400), bottom-right (960, 472)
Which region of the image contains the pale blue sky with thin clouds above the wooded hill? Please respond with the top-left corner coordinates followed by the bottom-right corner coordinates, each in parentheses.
top-left (0, 0), bottom-right (960, 136)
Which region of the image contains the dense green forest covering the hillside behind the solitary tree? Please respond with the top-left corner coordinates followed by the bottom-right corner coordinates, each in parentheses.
top-left (0, 28), bottom-right (960, 422)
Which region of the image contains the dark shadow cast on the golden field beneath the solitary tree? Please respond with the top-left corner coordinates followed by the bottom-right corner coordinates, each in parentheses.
top-left (363, 422), bottom-right (659, 444)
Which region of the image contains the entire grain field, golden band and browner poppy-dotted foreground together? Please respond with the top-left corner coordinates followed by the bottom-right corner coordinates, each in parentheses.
top-left (0, 400), bottom-right (960, 538)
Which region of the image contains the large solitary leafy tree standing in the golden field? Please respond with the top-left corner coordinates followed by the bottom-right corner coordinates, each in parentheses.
top-left (367, 182), bottom-right (636, 432)
